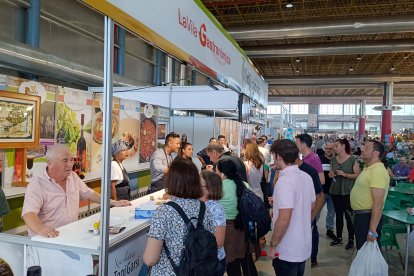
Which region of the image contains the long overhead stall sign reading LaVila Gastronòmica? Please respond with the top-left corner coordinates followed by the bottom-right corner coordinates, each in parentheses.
top-left (83, 0), bottom-right (268, 106)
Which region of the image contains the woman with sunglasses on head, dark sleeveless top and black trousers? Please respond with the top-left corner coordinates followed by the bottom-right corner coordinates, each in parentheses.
top-left (329, 138), bottom-right (360, 250)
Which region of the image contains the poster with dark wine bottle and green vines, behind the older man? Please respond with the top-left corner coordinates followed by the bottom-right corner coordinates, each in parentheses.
top-left (55, 87), bottom-right (93, 174)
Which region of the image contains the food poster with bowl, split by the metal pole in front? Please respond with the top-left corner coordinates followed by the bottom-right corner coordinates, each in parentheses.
top-left (92, 93), bottom-right (119, 177)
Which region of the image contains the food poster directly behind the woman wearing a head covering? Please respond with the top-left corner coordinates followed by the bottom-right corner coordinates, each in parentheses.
top-left (119, 99), bottom-right (141, 172)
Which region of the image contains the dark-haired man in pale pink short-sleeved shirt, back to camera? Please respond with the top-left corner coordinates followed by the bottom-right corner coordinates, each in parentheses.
top-left (270, 139), bottom-right (316, 275)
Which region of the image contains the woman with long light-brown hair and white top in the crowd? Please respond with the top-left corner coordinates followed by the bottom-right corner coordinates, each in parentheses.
top-left (244, 142), bottom-right (264, 200)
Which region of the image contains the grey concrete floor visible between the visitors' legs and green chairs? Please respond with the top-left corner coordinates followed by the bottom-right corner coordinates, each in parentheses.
top-left (256, 207), bottom-right (414, 276)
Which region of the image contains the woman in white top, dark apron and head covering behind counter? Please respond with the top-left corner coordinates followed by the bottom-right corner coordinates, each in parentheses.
top-left (111, 140), bottom-right (131, 200)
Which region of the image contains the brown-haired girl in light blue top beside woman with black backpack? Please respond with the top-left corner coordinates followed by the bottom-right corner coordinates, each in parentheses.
top-left (200, 170), bottom-right (226, 276)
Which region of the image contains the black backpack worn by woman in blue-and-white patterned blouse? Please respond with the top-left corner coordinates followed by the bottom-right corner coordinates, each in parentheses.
top-left (163, 201), bottom-right (220, 276)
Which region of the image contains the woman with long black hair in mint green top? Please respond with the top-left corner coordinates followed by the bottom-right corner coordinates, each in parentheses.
top-left (216, 159), bottom-right (260, 276)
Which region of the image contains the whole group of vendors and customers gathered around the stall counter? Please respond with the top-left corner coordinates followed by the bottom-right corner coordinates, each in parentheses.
top-left (16, 130), bottom-right (392, 276)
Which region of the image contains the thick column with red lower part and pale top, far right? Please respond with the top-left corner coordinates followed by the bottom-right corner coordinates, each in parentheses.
top-left (381, 82), bottom-right (394, 144)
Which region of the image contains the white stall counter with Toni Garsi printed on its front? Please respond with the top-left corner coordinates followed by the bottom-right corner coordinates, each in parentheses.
top-left (0, 190), bottom-right (164, 276)
